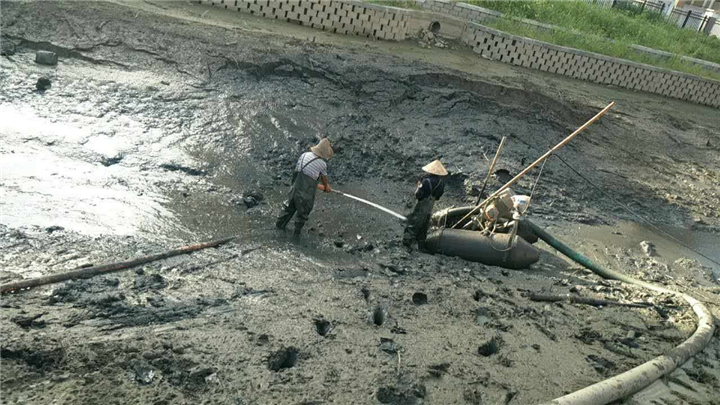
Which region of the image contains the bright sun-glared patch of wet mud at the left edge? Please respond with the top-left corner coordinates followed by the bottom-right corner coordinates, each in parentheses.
top-left (0, 104), bottom-right (183, 235)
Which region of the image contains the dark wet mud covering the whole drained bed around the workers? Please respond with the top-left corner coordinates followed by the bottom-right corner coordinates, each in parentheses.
top-left (0, 0), bottom-right (720, 404)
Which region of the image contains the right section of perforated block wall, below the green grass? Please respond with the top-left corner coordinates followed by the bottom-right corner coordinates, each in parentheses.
top-left (462, 23), bottom-right (720, 108)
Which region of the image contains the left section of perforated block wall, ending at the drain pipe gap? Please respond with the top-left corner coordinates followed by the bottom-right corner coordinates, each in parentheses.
top-left (198, 0), bottom-right (411, 41)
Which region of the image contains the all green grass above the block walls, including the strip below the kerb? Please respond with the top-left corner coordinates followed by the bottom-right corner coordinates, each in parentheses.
top-left (365, 0), bottom-right (720, 80)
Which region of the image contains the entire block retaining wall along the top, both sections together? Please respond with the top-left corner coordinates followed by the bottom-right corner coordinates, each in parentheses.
top-left (197, 0), bottom-right (720, 108)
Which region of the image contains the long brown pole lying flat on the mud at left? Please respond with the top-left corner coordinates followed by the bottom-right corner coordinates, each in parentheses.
top-left (0, 236), bottom-right (236, 294)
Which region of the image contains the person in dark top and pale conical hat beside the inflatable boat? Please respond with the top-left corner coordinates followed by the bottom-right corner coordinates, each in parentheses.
top-left (403, 160), bottom-right (448, 251)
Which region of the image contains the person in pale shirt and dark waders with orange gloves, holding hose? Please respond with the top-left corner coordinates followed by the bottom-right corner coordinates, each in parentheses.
top-left (275, 138), bottom-right (333, 236)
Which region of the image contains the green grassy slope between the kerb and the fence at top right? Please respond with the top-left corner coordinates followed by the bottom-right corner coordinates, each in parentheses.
top-left (466, 0), bottom-right (720, 63)
